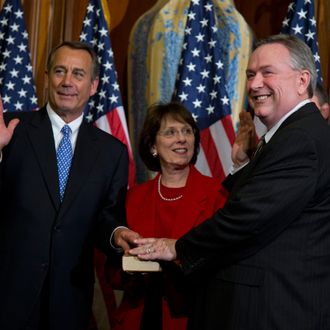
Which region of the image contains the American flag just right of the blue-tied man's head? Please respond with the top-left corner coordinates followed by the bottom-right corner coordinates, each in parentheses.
top-left (80, 0), bottom-right (135, 187)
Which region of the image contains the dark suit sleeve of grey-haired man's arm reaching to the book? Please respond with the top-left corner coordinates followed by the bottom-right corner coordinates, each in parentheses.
top-left (176, 129), bottom-right (318, 273)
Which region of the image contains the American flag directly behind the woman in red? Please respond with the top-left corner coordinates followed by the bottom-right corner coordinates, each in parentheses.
top-left (174, 0), bottom-right (235, 179)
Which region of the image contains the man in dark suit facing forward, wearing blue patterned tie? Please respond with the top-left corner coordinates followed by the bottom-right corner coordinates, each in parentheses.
top-left (0, 42), bottom-right (138, 330)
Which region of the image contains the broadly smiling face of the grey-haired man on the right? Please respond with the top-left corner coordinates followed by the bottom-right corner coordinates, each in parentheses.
top-left (246, 43), bottom-right (310, 129)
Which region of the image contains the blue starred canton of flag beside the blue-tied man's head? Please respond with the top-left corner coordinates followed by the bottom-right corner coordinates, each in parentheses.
top-left (80, 0), bottom-right (122, 122)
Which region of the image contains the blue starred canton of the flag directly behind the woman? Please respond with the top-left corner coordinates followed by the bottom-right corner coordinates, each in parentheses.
top-left (174, 0), bottom-right (231, 129)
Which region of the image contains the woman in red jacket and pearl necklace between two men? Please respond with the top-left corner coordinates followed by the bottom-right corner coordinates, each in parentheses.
top-left (114, 102), bottom-right (226, 330)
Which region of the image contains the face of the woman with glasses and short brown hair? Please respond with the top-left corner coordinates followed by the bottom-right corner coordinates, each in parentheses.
top-left (151, 117), bottom-right (195, 172)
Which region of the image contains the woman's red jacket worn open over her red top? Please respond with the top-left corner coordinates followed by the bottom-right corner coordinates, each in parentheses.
top-left (114, 166), bottom-right (227, 330)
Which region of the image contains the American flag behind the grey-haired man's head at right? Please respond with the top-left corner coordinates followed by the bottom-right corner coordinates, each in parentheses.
top-left (282, 0), bottom-right (323, 84)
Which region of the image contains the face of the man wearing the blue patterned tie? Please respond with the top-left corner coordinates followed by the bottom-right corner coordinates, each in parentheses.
top-left (46, 46), bottom-right (98, 122)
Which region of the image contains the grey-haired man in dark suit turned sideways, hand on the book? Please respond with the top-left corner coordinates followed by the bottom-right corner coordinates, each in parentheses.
top-left (130, 35), bottom-right (330, 330)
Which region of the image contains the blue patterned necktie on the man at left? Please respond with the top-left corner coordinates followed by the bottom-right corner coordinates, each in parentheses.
top-left (56, 125), bottom-right (72, 201)
